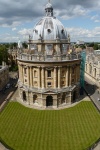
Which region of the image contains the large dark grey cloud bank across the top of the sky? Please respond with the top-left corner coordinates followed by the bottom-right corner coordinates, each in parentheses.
top-left (0, 0), bottom-right (100, 27)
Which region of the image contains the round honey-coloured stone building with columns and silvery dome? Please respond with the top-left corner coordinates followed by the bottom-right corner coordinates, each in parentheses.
top-left (18, 3), bottom-right (81, 107)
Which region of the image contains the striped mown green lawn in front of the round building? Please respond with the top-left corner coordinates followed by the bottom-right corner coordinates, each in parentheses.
top-left (0, 101), bottom-right (100, 150)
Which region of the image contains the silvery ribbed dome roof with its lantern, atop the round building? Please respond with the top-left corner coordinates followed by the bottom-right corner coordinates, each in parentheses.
top-left (32, 3), bottom-right (67, 40)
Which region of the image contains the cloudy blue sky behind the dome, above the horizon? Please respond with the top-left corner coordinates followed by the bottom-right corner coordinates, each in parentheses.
top-left (0, 0), bottom-right (100, 42)
